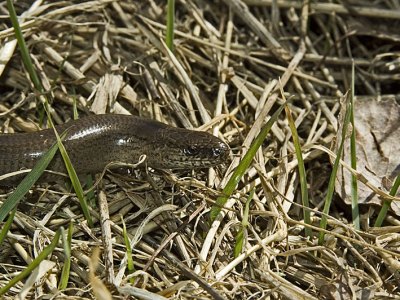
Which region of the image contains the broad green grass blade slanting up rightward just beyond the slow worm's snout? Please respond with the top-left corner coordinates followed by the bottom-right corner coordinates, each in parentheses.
top-left (210, 103), bottom-right (285, 221)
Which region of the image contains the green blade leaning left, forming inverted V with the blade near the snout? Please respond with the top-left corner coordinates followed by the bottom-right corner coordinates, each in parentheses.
top-left (282, 105), bottom-right (312, 239)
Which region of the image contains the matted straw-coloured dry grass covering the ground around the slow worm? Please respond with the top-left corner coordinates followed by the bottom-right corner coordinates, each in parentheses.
top-left (0, 0), bottom-right (400, 299)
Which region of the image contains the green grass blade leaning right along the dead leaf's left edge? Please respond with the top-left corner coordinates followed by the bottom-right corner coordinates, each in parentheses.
top-left (318, 102), bottom-right (351, 245)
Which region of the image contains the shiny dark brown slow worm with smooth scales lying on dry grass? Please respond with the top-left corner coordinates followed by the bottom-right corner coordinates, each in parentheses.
top-left (0, 114), bottom-right (229, 186)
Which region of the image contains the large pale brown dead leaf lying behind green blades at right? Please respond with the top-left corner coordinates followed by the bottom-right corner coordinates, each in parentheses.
top-left (335, 99), bottom-right (400, 215)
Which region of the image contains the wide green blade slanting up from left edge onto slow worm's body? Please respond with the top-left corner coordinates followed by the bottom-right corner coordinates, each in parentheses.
top-left (0, 139), bottom-right (58, 222)
